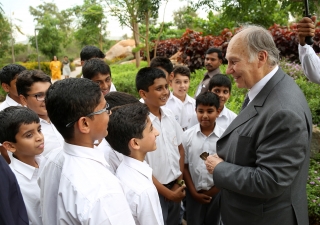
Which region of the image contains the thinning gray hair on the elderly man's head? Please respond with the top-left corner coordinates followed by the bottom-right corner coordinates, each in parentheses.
top-left (241, 25), bottom-right (280, 66)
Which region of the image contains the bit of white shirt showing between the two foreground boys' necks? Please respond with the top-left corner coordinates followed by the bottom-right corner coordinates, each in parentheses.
top-left (95, 139), bottom-right (123, 174)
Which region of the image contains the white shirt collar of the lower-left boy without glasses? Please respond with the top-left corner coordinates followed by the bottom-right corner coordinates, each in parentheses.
top-left (10, 155), bottom-right (43, 180)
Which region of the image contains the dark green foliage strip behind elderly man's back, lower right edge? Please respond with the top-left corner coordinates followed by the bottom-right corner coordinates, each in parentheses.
top-left (307, 154), bottom-right (320, 224)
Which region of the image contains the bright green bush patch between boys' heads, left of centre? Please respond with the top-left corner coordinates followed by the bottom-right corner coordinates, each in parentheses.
top-left (110, 61), bottom-right (147, 98)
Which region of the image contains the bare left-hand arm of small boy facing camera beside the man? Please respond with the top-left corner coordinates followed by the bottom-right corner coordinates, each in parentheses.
top-left (183, 164), bottom-right (212, 204)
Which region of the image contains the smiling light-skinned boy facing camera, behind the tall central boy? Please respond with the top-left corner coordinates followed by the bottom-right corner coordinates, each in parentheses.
top-left (166, 66), bottom-right (197, 130)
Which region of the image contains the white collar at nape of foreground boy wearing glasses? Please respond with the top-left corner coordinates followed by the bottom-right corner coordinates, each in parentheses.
top-left (63, 142), bottom-right (109, 166)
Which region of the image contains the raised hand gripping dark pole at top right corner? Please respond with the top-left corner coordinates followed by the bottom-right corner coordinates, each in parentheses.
top-left (297, 16), bottom-right (317, 46)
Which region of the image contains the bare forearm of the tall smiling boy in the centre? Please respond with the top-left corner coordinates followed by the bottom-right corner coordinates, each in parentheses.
top-left (152, 175), bottom-right (186, 202)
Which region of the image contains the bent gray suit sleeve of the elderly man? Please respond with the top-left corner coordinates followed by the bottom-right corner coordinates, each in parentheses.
top-left (213, 110), bottom-right (310, 198)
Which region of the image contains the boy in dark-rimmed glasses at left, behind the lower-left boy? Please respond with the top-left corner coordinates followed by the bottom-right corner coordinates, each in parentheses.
top-left (16, 70), bottom-right (64, 157)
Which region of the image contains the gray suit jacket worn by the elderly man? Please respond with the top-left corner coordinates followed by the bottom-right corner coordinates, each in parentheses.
top-left (213, 69), bottom-right (312, 225)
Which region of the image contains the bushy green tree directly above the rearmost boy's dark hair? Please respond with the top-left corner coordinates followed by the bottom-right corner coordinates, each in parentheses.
top-left (73, 0), bottom-right (107, 50)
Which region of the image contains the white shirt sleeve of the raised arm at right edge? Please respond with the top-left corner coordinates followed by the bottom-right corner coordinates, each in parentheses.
top-left (299, 44), bottom-right (320, 84)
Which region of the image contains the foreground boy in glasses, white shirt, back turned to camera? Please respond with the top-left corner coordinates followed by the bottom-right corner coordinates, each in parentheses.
top-left (39, 79), bottom-right (135, 225)
